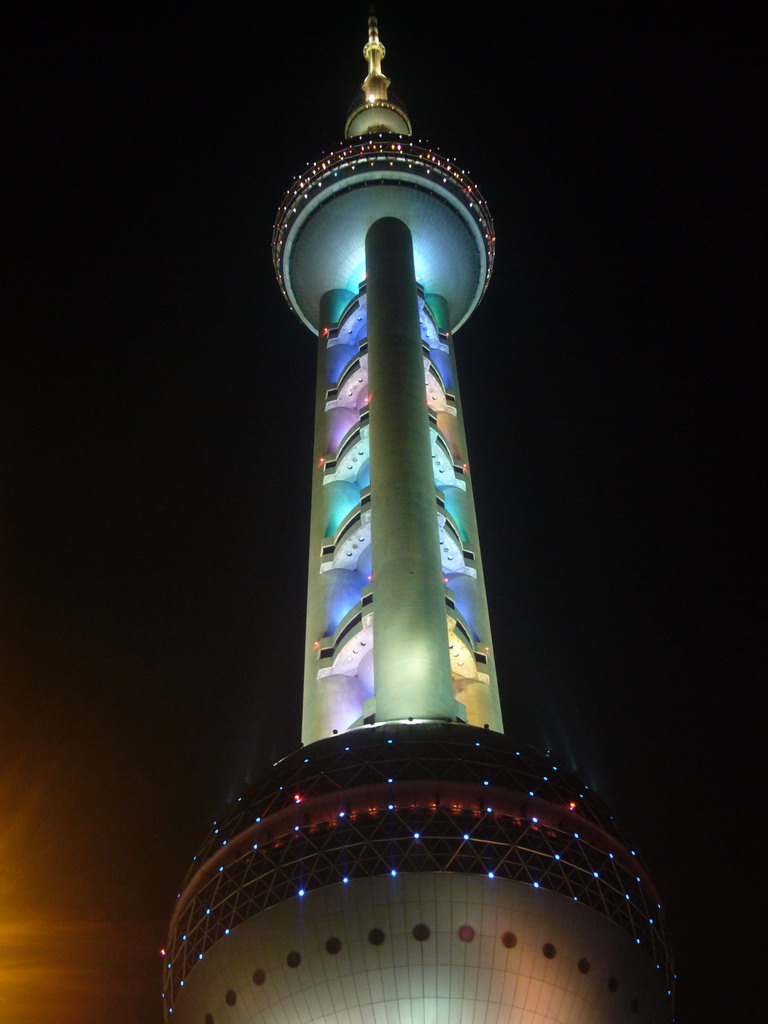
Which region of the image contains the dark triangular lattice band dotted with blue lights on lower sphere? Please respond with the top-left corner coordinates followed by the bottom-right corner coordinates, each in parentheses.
top-left (166, 723), bottom-right (673, 1006)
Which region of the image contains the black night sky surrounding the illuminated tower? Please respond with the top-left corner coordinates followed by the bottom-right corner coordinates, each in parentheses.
top-left (0, 2), bottom-right (766, 1024)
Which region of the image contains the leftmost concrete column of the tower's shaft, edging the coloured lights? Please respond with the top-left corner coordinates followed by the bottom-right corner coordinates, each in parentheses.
top-left (301, 289), bottom-right (353, 743)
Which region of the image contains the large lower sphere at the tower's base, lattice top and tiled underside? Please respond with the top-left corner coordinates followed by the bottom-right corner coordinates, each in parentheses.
top-left (165, 723), bottom-right (672, 1024)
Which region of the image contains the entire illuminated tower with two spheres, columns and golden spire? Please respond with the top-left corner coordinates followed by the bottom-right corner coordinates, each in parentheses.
top-left (163, 17), bottom-right (673, 1024)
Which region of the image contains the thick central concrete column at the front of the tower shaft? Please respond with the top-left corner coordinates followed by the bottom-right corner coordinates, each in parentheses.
top-left (366, 217), bottom-right (456, 722)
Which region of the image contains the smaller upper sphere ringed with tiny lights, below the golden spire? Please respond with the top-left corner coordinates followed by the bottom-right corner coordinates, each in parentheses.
top-left (272, 136), bottom-right (496, 333)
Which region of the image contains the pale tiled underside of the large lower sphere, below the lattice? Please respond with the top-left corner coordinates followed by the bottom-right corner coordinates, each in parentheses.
top-left (171, 874), bottom-right (669, 1024)
